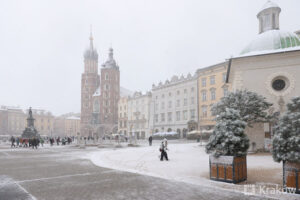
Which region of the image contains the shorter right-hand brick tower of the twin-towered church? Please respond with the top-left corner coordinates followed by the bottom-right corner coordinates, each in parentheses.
top-left (100, 48), bottom-right (120, 126)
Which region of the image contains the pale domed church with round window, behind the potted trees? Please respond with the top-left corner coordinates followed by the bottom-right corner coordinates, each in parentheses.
top-left (226, 1), bottom-right (300, 150)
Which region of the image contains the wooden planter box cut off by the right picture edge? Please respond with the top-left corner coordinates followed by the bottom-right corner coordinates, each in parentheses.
top-left (283, 161), bottom-right (300, 194)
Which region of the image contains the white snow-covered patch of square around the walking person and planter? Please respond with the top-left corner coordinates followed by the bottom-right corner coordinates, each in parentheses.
top-left (88, 143), bottom-right (299, 199)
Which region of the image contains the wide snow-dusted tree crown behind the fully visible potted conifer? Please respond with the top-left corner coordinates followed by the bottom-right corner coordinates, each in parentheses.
top-left (211, 90), bottom-right (272, 126)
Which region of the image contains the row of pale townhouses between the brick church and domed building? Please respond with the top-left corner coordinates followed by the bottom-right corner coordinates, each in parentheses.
top-left (118, 61), bottom-right (231, 139)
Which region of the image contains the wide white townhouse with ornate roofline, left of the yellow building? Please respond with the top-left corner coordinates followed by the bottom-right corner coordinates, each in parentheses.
top-left (150, 74), bottom-right (198, 138)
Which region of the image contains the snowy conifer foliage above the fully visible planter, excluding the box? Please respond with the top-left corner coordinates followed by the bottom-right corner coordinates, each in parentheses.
top-left (206, 108), bottom-right (249, 157)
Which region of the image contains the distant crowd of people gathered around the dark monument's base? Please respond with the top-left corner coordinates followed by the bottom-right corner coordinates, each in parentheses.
top-left (10, 136), bottom-right (74, 149)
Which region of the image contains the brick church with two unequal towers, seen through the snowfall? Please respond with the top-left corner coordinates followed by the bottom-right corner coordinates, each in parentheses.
top-left (80, 32), bottom-right (120, 137)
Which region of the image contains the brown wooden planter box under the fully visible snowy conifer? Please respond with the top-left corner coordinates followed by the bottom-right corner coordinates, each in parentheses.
top-left (209, 155), bottom-right (247, 183)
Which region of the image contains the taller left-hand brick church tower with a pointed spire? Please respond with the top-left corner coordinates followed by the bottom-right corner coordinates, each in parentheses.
top-left (80, 33), bottom-right (100, 136)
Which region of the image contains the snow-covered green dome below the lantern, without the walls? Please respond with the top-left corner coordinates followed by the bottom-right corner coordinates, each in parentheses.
top-left (241, 30), bottom-right (300, 55)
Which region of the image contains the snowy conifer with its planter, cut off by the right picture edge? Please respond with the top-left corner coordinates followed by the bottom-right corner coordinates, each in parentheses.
top-left (272, 97), bottom-right (300, 194)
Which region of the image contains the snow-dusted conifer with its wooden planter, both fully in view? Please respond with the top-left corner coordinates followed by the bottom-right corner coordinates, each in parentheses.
top-left (206, 108), bottom-right (249, 183)
